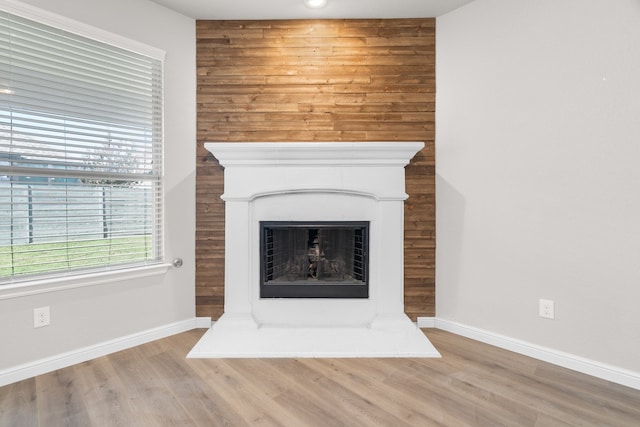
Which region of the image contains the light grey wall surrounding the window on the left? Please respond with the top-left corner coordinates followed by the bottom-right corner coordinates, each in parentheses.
top-left (0, 0), bottom-right (196, 371)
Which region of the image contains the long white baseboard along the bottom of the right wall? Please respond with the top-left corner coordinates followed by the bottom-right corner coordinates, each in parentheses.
top-left (435, 318), bottom-right (640, 390)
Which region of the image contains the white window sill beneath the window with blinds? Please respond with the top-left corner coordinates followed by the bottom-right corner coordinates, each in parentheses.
top-left (0, 264), bottom-right (171, 300)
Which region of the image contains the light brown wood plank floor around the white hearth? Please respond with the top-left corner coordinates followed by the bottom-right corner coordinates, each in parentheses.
top-left (0, 329), bottom-right (640, 427)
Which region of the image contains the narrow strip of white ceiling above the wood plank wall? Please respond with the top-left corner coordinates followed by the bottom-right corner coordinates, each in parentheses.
top-left (146, 0), bottom-right (473, 20)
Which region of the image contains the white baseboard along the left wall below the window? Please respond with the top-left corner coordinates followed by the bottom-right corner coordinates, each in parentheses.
top-left (0, 317), bottom-right (199, 387)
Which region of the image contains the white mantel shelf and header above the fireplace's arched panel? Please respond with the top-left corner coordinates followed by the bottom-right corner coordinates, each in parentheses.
top-left (205, 142), bottom-right (424, 201)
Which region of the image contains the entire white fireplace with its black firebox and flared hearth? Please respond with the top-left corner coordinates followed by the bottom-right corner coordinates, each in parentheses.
top-left (189, 142), bottom-right (438, 357)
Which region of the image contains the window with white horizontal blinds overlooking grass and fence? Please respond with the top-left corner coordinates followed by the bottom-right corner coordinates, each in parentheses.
top-left (0, 11), bottom-right (163, 284)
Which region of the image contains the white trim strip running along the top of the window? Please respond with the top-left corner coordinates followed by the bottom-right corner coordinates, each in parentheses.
top-left (0, 0), bottom-right (166, 61)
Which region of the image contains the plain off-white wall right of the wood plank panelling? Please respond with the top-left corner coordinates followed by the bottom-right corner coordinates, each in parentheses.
top-left (436, 0), bottom-right (640, 371)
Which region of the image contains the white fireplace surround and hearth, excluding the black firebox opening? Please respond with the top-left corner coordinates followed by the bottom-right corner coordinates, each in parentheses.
top-left (189, 142), bottom-right (439, 357)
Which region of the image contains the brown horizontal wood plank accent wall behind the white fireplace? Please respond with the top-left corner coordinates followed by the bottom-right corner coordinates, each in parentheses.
top-left (195, 19), bottom-right (435, 320)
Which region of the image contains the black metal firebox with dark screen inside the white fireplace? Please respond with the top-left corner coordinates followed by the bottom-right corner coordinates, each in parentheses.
top-left (260, 221), bottom-right (369, 298)
